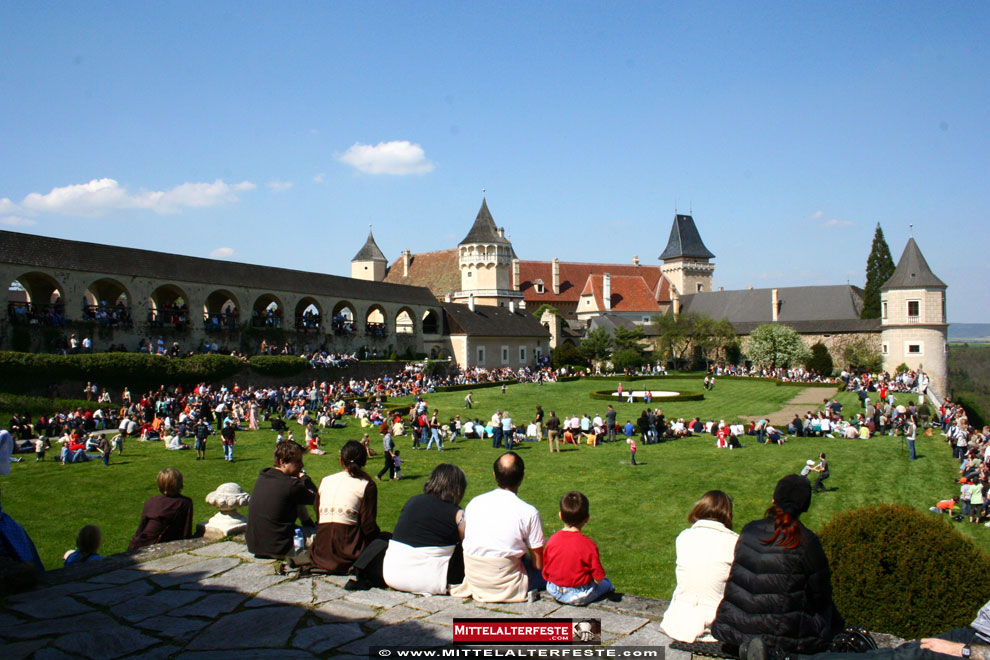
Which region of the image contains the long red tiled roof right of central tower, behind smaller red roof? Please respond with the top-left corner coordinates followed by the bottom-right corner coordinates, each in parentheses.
top-left (519, 261), bottom-right (670, 306)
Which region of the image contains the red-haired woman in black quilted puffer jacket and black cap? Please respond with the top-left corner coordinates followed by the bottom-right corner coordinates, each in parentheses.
top-left (712, 474), bottom-right (843, 658)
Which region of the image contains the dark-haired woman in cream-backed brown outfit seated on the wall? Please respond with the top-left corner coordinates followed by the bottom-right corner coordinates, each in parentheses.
top-left (310, 440), bottom-right (380, 588)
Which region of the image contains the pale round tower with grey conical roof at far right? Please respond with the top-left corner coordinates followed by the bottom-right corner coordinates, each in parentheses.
top-left (880, 238), bottom-right (949, 397)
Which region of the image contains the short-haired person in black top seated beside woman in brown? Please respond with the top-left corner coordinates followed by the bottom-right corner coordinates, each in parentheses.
top-left (244, 440), bottom-right (316, 559)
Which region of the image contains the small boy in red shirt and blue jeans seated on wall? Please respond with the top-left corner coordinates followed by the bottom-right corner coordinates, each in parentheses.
top-left (543, 490), bottom-right (614, 605)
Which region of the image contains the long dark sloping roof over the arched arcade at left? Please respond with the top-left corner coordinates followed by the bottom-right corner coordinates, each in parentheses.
top-left (0, 231), bottom-right (436, 305)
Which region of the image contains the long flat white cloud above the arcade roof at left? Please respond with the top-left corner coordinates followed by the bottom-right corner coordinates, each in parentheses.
top-left (15, 178), bottom-right (255, 216)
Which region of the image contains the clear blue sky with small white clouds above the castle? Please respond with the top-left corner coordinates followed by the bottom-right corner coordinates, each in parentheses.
top-left (0, 2), bottom-right (990, 322)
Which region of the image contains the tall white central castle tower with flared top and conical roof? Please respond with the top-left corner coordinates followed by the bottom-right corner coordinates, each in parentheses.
top-left (454, 198), bottom-right (523, 307)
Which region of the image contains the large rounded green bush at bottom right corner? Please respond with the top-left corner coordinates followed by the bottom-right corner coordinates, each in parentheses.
top-left (821, 504), bottom-right (990, 639)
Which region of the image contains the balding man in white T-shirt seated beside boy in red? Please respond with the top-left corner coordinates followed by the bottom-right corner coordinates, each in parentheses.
top-left (463, 451), bottom-right (546, 602)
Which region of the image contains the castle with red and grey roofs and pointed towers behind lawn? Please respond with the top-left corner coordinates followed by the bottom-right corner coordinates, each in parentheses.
top-left (351, 199), bottom-right (948, 395)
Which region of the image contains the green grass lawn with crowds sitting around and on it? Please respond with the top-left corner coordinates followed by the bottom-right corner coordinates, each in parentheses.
top-left (0, 379), bottom-right (976, 598)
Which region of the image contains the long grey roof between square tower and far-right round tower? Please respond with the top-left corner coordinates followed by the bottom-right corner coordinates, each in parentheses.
top-left (681, 284), bottom-right (880, 334)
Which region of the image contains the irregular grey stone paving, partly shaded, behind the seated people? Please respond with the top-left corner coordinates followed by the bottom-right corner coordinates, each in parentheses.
top-left (0, 540), bottom-right (690, 660)
